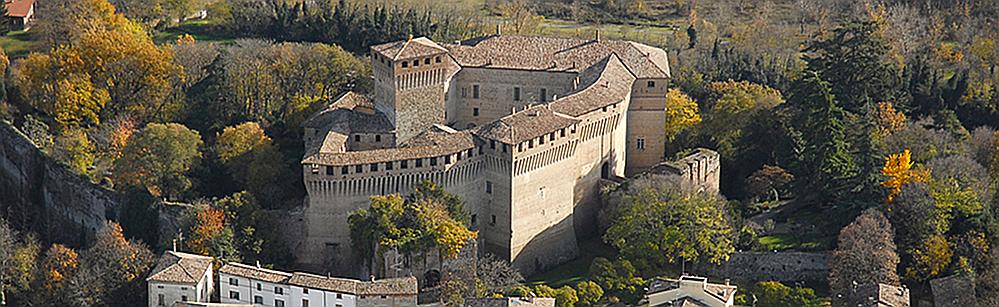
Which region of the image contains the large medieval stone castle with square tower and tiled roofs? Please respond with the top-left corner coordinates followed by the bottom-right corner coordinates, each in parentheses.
top-left (298, 31), bottom-right (670, 275)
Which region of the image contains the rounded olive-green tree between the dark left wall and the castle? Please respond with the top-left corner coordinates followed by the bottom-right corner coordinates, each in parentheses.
top-left (114, 123), bottom-right (202, 198)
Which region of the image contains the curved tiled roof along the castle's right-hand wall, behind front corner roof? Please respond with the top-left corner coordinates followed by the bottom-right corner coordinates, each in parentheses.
top-left (552, 54), bottom-right (635, 116)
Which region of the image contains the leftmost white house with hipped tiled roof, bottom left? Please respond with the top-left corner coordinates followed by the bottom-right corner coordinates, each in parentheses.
top-left (146, 251), bottom-right (215, 306)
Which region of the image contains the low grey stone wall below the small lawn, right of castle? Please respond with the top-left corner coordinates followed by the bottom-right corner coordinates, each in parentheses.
top-left (691, 252), bottom-right (829, 283)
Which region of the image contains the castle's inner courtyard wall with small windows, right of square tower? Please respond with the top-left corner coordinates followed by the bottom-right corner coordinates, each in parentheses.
top-left (447, 67), bottom-right (576, 129)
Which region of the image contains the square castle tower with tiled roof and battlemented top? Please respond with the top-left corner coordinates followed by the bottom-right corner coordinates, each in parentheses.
top-left (371, 37), bottom-right (459, 144)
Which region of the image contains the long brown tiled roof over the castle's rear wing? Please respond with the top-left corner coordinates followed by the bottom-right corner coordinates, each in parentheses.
top-left (444, 35), bottom-right (670, 78)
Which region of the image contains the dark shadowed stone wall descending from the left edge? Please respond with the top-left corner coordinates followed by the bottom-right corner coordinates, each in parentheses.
top-left (0, 122), bottom-right (119, 246)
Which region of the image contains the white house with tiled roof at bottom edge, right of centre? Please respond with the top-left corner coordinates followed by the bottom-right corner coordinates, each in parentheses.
top-left (638, 276), bottom-right (736, 307)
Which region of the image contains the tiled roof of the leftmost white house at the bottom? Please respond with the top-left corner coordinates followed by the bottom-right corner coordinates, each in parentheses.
top-left (146, 251), bottom-right (212, 284)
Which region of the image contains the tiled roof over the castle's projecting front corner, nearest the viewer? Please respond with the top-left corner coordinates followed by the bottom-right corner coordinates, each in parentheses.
top-left (475, 105), bottom-right (579, 144)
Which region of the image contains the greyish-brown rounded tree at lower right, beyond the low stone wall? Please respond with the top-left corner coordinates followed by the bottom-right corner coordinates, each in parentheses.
top-left (829, 209), bottom-right (899, 304)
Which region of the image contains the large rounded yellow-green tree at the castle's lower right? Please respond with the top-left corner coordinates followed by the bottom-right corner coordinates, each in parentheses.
top-left (604, 178), bottom-right (735, 272)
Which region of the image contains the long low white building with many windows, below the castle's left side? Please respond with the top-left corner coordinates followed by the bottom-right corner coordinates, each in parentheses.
top-left (219, 263), bottom-right (417, 307)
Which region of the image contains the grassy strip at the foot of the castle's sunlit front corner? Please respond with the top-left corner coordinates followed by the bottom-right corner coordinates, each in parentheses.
top-left (527, 238), bottom-right (617, 288)
